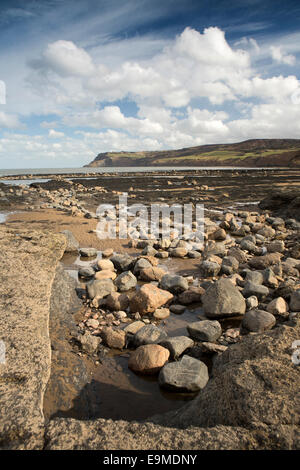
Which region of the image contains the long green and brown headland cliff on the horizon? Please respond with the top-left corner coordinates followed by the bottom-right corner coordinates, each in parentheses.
top-left (85, 139), bottom-right (300, 168)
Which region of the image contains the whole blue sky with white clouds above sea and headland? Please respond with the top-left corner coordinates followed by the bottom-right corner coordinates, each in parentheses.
top-left (0, 0), bottom-right (300, 168)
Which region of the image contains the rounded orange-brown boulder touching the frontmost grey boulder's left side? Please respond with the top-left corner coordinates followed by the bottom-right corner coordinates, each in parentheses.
top-left (128, 344), bottom-right (170, 375)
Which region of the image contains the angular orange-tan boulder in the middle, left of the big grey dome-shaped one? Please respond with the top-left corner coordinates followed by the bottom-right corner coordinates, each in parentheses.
top-left (130, 284), bottom-right (173, 315)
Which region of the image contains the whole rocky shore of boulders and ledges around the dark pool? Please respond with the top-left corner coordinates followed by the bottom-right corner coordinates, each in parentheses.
top-left (0, 171), bottom-right (300, 449)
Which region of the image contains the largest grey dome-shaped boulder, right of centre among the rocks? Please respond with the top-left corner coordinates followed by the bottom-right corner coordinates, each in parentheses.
top-left (202, 279), bottom-right (246, 318)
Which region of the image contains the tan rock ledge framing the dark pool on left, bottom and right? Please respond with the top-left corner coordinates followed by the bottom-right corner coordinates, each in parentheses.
top-left (0, 227), bottom-right (300, 450)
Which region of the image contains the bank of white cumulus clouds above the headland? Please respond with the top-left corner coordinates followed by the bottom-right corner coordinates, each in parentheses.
top-left (0, 27), bottom-right (300, 167)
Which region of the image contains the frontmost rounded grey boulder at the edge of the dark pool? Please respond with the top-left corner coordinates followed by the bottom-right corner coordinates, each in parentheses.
top-left (158, 356), bottom-right (209, 392)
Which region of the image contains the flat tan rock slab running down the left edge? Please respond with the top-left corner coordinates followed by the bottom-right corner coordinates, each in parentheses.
top-left (0, 227), bottom-right (66, 449)
